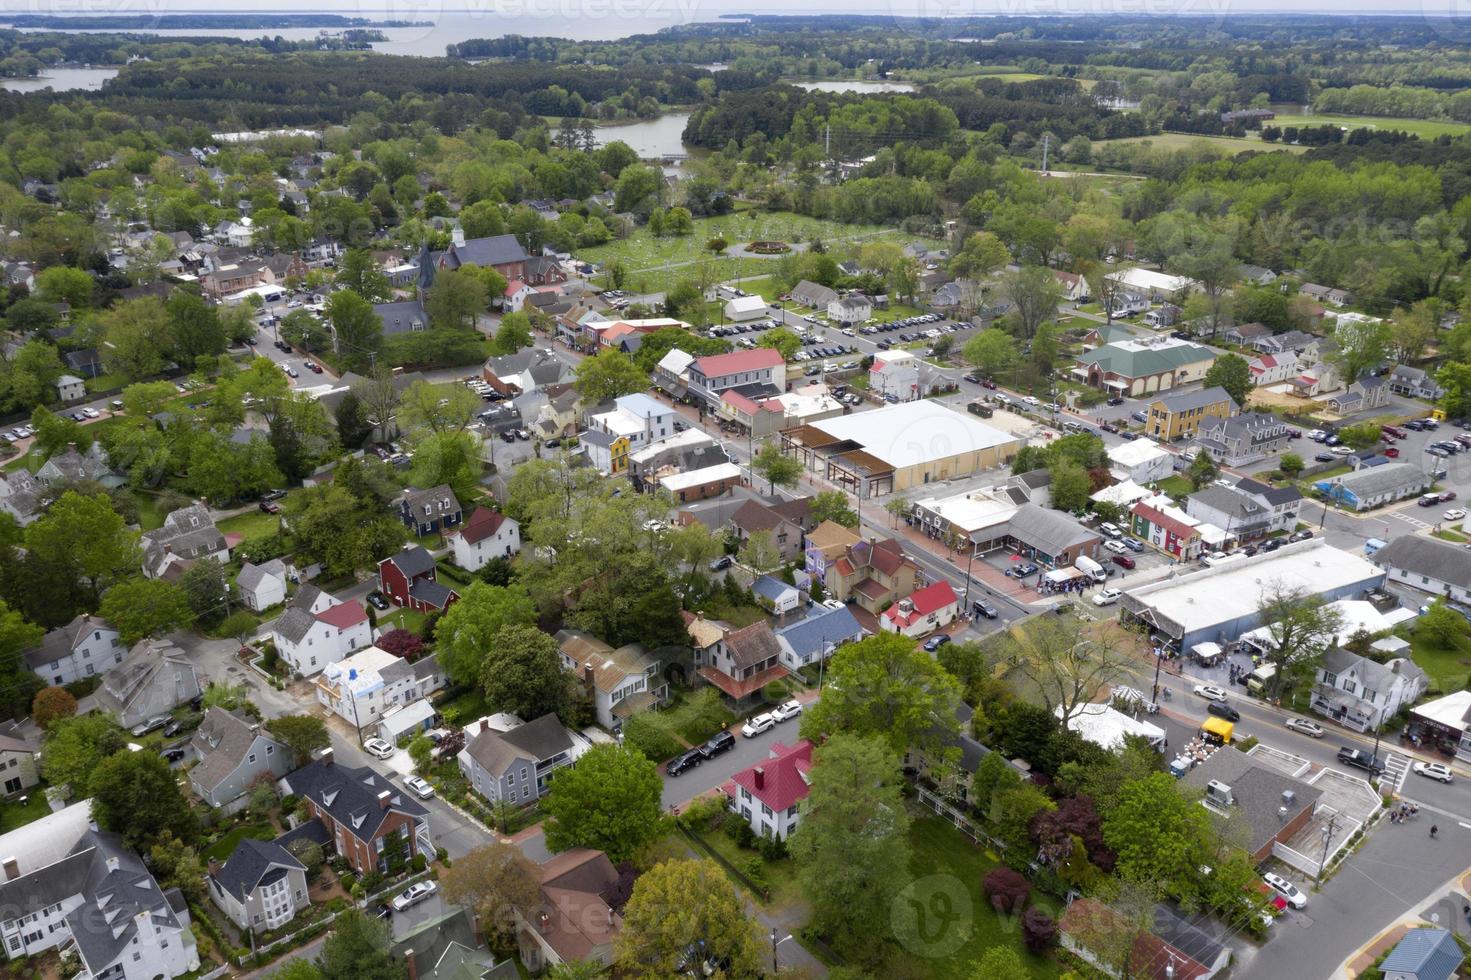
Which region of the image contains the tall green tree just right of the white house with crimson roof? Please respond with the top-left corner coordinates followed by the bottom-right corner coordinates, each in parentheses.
top-left (788, 732), bottom-right (909, 967)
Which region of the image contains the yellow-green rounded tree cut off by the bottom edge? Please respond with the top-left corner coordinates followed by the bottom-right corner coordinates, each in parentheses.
top-left (614, 853), bottom-right (762, 980)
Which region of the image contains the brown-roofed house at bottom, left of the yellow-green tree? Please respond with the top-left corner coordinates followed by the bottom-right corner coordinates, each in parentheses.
top-left (517, 848), bottom-right (624, 980)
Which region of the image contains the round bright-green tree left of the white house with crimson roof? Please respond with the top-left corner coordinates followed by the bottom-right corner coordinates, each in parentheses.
top-left (541, 743), bottom-right (663, 864)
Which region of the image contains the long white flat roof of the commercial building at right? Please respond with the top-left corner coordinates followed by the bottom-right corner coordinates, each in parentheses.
top-left (1124, 537), bottom-right (1384, 633)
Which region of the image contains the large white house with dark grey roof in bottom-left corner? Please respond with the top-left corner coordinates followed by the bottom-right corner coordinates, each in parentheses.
top-left (0, 828), bottom-right (200, 980)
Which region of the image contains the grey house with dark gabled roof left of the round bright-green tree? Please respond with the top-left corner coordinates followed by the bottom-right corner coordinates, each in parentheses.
top-left (455, 714), bottom-right (588, 806)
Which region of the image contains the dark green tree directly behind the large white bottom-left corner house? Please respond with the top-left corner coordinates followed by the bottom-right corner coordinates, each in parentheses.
top-left (87, 752), bottom-right (199, 848)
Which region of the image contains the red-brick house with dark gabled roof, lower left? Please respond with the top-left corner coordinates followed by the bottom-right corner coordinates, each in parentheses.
top-left (281, 749), bottom-right (434, 874)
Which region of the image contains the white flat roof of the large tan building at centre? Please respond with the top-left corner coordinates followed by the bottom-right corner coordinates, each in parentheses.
top-left (812, 400), bottom-right (1021, 469)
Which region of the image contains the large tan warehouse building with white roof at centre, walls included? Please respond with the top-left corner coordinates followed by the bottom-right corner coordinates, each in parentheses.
top-left (781, 400), bottom-right (1025, 497)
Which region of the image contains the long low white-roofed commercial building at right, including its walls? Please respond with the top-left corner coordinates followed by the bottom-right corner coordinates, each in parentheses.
top-left (1119, 539), bottom-right (1384, 650)
